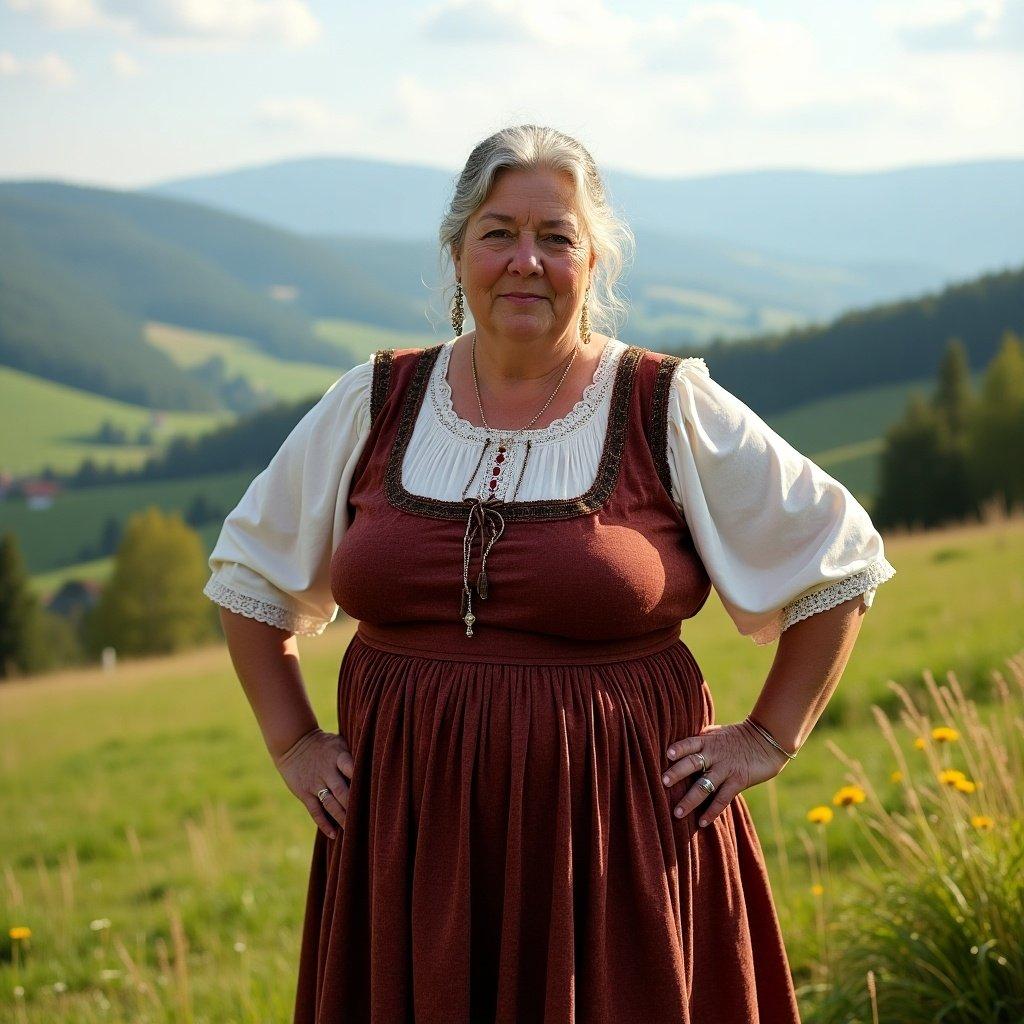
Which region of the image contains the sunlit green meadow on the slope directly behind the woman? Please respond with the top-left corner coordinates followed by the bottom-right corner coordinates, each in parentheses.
top-left (0, 517), bottom-right (1024, 1024)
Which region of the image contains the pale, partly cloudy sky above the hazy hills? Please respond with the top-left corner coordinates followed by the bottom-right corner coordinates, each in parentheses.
top-left (0, 0), bottom-right (1024, 187)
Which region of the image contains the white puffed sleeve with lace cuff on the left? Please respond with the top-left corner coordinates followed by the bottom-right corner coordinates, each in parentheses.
top-left (203, 357), bottom-right (373, 636)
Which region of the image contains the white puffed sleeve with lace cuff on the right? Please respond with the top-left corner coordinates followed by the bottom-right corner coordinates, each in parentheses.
top-left (668, 356), bottom-right (896, 644)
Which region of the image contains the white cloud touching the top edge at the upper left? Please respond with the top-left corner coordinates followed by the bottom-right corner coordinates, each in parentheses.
top-left (7, 0), bottom-right (322, 48)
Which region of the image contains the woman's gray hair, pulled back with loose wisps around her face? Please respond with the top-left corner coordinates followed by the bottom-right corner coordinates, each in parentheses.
top-left (438, 125), bottom-right (636, 337)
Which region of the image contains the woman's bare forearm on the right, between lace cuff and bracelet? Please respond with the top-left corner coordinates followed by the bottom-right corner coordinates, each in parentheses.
top-left (751, 595), bottom-right (867, 754)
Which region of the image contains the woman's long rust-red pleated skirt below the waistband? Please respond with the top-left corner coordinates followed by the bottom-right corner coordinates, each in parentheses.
top-left (294, 633), bottom-right (799, 1024)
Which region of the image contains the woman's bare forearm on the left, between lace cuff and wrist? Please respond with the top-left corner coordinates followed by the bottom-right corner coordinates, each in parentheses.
top-left (220, 608), bottom-right (317, 761)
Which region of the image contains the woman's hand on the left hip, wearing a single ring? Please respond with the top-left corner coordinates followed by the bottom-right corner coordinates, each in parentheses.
top-left (273, 728), bottom-right (355, 839)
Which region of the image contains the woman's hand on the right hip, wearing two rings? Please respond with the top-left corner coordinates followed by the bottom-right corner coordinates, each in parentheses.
top-left (662, 722), bottom-right (790, 827)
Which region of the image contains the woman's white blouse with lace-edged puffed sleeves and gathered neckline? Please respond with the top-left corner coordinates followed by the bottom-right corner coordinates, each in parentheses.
top-left (203, 338), bottom-right (896, 644)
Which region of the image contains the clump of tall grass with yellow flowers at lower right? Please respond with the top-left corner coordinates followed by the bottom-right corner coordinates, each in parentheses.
top-left (803, 652), bottom-right (1024, 1024)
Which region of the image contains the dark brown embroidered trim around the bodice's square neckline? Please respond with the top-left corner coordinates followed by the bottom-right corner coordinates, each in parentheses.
top-left (384, 344), bottom-right (645, 522)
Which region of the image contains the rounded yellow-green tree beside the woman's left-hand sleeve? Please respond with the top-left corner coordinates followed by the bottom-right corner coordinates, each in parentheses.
top-left (85, 507), bottom-right (216, 654)
